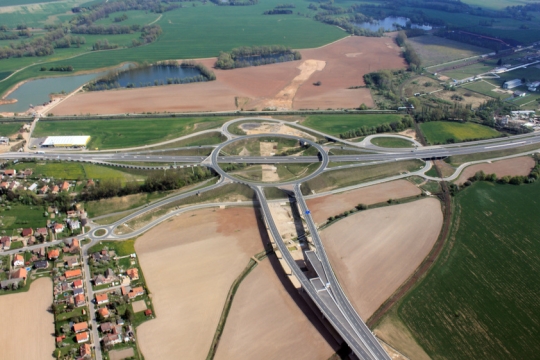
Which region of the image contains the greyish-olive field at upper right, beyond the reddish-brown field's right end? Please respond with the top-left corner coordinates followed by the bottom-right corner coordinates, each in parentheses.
top-left (409, 36), bottom-right (491, 67)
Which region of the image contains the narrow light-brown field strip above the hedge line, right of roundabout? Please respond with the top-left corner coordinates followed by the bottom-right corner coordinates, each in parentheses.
top-left (306, 180), bottom-right (422, 224)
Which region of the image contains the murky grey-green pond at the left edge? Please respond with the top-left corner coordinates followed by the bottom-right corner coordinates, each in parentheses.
top-left (0, 65), bottom-right (128, 112)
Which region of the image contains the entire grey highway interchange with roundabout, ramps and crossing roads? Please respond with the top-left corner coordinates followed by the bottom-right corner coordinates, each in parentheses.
top-left (0, 118), bottom-right (540, 359)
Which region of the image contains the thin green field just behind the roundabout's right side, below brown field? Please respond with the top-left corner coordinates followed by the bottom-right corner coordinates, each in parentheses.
top-left (301, 114), bottom-right (402, 136)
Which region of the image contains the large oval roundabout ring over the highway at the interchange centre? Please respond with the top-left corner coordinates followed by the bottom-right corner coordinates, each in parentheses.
top-left (210, 134), bottom-right (330, 187)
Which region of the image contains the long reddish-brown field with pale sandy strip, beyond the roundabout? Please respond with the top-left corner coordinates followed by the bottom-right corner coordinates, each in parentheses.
top-left (51, 36), bottom-right (405, 115)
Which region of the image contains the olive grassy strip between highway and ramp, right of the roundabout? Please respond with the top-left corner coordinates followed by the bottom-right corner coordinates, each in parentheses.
top-left (302, 160), bottom-right (424, 195)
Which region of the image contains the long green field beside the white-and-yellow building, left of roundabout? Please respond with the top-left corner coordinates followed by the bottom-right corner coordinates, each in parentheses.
top-left (33, 116), bottom-right (230, 150)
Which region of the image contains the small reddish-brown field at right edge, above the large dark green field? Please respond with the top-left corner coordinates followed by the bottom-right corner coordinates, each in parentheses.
top-left (456, 156), bottom-right (534, 185)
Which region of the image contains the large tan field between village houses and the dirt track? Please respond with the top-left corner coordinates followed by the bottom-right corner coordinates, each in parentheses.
top-left (135, 207), bottom-right (268, 359)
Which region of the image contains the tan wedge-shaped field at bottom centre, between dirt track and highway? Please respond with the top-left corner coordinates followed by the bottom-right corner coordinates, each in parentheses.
top-left (215, 257), bottom-right (337, 360)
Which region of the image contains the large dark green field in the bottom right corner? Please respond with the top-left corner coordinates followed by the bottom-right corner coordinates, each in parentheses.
top-left (398, 182), bottom-right (540, 359)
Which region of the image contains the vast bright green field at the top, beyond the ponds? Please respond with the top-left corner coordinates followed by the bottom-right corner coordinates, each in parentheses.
top-left (0, 0), bottom-right (347, 94)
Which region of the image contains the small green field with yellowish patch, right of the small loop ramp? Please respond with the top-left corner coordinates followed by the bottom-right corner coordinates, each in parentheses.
top-left (420, 121), bottom-right (501, 144)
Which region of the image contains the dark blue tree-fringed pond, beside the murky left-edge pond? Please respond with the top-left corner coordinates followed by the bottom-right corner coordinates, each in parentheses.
top-left (117, 66), bottom-right (201, 87)
